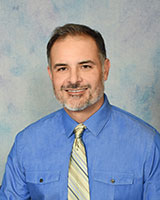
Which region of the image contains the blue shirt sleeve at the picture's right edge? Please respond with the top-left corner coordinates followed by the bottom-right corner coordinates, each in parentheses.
top-left (143, 132), bottom-right (160, 200)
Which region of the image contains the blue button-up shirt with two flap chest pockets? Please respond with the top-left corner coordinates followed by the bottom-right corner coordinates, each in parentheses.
top-left (0, 96), bottom-right (160, 200)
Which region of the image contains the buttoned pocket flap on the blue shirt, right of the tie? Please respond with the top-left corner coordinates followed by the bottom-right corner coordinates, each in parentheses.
top-left (93, 171), bottom-right (134, 185)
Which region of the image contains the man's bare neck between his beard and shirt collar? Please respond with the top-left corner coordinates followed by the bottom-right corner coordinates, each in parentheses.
top-left (64, 96), bottom-right (104, 123)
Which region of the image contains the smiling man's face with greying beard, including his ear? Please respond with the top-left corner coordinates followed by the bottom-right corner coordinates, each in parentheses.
top-left (48, 36), bottom-right (109, 111)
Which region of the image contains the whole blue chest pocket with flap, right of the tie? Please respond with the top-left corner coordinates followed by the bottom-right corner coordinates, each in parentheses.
top-left (92, 171), bottom-right (134, 200)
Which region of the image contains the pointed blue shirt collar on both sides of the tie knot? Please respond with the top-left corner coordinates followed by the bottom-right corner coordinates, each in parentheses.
top-left (62, 94), bottom-right (111, 137)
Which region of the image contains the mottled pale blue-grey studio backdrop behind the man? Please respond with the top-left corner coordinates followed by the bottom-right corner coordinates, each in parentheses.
top-left (0, 0), bottom-right (160, 182)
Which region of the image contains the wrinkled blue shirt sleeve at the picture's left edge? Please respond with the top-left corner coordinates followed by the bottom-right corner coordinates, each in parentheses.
top-left (0, 135), bottom-right (30, 200)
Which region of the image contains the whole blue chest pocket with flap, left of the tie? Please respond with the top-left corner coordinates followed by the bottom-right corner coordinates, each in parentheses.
top-left (26, 171), bottom-right (60, 200)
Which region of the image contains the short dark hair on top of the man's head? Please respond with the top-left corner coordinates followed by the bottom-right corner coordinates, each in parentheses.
top-left (47, 24), bottom-right (107, 64)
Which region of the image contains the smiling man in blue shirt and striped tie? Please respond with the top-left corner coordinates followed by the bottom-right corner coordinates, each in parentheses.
top-left (0, 24), bottom-right (160, 200)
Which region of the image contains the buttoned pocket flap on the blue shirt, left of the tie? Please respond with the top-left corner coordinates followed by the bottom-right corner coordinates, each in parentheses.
top-left (26, 171), bottom-right (60, 184)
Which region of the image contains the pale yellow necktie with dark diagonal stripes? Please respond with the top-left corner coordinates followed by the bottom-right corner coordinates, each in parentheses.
top-left (68, 124), bottom-right (90, 200)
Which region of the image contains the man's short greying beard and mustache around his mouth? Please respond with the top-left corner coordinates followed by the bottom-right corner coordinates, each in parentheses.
top-left (53, 76), bottom-right (104, 111)
